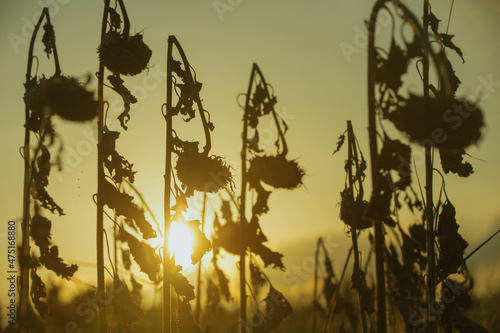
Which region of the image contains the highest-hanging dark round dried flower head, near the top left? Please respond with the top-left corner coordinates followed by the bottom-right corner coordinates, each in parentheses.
top-left (97, 30), bottom-right (152, 76)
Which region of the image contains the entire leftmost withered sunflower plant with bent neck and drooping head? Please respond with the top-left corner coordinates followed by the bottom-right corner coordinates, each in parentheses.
top-left (17, 8), bottom-right (97, 332)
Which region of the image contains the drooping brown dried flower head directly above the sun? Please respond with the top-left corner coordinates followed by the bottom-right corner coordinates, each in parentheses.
top-left (175, 150), bottom-right (233, 193)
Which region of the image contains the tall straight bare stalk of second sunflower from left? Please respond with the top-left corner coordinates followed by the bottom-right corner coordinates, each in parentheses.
top-left (96, 0), bottom-right (110, 333)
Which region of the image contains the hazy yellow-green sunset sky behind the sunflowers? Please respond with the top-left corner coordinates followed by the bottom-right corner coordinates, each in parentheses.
top-left (0, 0), bottom-right (500, 324)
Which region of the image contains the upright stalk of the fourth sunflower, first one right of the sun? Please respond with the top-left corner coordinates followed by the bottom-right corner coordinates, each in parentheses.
top-left (239, 63), bottom-right (257, 333)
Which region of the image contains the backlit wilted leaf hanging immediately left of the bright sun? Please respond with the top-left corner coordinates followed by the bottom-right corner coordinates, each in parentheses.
top-left (118, 229), bottom-right (161, 283)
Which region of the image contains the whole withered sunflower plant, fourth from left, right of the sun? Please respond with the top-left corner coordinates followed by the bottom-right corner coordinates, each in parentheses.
top-left (210, 64), bottom-right (304, 332)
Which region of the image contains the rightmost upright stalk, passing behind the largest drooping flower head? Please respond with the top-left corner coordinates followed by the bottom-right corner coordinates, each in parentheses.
top-left (422, 0), bottom-right (437, 333)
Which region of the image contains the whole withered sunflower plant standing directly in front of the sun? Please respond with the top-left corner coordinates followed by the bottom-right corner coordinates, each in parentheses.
top-left (162, 36), bottom-right (233, 332)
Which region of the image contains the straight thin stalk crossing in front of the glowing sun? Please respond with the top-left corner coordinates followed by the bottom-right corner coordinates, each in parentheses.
top-left (162, 36), bottom-right (175, 333)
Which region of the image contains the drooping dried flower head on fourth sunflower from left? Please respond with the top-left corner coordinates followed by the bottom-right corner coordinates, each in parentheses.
top-left (248, 155), bottom-right (304, 190)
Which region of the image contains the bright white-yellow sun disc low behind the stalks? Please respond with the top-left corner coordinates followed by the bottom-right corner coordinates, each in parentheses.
top-left (168, 222), bottom-right (194, 269)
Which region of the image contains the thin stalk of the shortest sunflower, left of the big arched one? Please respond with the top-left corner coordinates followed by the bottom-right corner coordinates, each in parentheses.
top-left (347, 120), bottom-right (368, 333)
